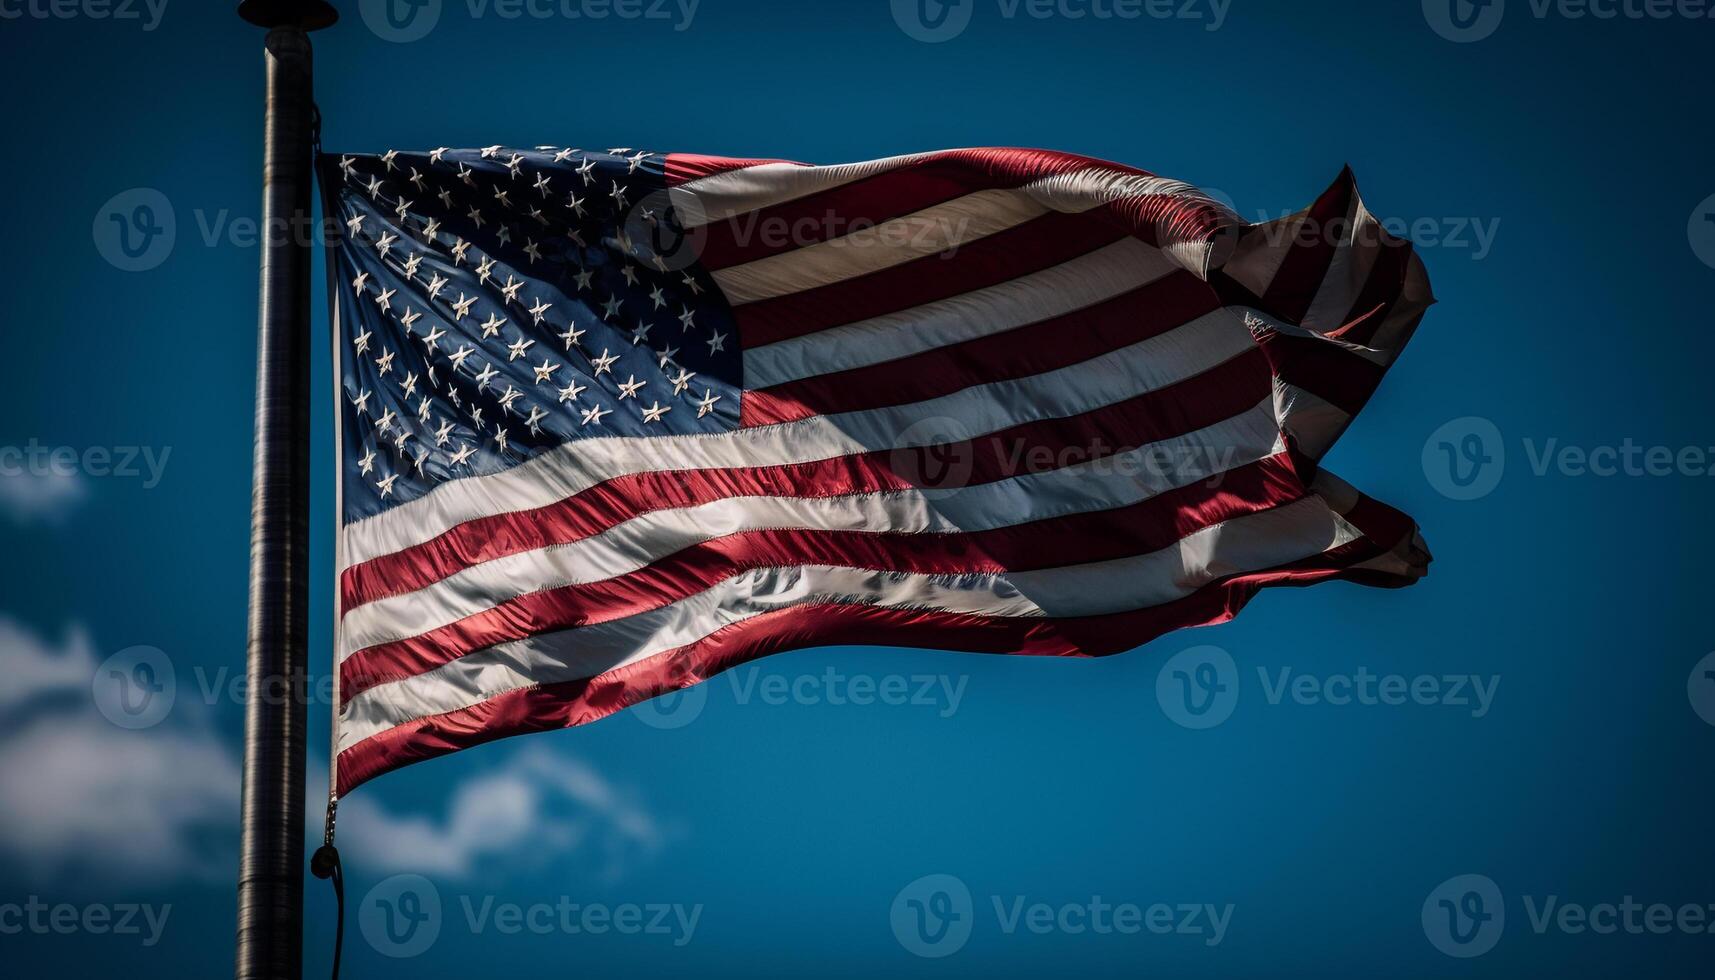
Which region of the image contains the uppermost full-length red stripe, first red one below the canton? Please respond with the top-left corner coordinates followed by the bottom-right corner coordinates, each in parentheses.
top-left (340, 348), bottom-right (1273, 611)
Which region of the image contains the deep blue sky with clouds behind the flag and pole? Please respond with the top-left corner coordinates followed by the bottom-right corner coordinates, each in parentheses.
top-left (0, 0), bottom-right (1715, 977)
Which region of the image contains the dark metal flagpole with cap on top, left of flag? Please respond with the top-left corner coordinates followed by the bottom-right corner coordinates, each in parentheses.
top-left (233, 0), bottom-right (338, 980)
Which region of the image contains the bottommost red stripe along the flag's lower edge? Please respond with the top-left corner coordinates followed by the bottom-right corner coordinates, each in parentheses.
top-left (338, 539), bottom-right (1379, 796)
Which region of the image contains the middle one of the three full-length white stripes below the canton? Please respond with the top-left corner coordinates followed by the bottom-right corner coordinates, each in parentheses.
top-left (340, 402), bottom-right (1285, 661)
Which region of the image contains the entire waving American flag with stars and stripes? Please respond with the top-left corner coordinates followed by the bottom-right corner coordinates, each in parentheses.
top-left (321, 146), bottom-right (1432, 793)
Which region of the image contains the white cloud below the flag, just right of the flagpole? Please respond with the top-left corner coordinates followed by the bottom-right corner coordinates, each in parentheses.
top-left (324, 745), bottom-right (676, 879)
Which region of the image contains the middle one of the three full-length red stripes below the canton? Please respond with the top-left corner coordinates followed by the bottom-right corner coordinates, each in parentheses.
top-left (340, 457), bottom-right (1307, 700)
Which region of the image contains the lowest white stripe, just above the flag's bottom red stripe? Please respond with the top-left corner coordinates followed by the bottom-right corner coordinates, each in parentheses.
top-left (340, 496), bottom-right (1358, 750)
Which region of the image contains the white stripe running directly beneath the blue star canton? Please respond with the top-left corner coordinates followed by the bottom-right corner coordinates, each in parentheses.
top-left (334, 311), bottom-right (1252, 565)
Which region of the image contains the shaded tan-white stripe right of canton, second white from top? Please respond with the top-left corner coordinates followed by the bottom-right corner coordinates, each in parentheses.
top-left (715, 189), bottom-right (1048, 305)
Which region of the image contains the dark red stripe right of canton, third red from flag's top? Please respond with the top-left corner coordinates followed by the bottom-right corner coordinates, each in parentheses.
top-left (732, 211), bottom-right (1127, 350)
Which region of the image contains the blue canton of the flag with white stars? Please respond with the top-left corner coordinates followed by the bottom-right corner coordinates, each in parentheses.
top-left (321, 146), bottom-right (743, 522)
